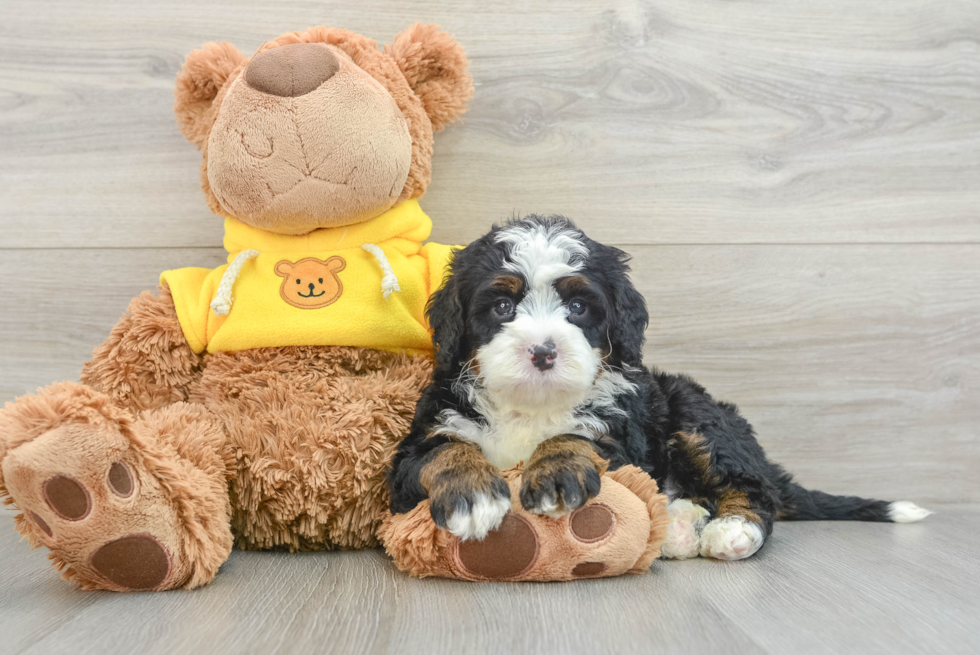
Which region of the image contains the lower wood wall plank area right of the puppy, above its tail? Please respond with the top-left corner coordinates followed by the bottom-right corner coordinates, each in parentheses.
top-left (630, 246), bottom-right (980, 502)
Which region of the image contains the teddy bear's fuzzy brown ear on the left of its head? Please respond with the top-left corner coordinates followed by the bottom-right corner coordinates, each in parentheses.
top-left (174, 41), bottom-right (245, 147)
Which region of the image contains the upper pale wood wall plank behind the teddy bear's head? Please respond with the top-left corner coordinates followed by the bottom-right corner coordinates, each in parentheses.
top-left (0, 0), bottom-right (980, 248)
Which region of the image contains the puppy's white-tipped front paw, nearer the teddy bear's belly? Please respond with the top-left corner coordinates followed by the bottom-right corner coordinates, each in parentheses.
top-left (429, 474), bottom-right (510, 541)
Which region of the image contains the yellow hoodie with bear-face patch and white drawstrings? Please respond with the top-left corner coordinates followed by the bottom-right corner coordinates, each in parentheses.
top-left (160, 200), bottom-right (452, 353)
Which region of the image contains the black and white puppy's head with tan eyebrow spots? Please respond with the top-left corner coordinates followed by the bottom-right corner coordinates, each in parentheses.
top-left (429, 216), bottom-right (648, 411)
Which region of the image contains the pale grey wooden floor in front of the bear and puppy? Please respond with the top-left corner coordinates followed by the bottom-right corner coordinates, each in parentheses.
top-left (0, 506), bottom-right (980, 655)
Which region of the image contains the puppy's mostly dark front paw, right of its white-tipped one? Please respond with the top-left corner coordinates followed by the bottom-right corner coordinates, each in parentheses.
top-left (521, 452), bottom-right (602, 518)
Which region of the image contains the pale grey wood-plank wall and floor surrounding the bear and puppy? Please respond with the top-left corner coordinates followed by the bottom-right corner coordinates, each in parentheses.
top-left (0, 0), bottom-right (980, 654)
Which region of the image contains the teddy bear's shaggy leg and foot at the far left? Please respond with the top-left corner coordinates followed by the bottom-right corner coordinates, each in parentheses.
top-left (0, 383), bottom-right (232, 591)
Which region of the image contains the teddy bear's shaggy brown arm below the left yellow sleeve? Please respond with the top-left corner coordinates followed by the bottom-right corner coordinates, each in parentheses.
top-left (81, 285), bottom-right (203, 412)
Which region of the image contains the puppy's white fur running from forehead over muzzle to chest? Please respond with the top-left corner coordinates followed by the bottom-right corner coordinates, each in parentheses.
top-left (436, 222), bottom-right (608, 468)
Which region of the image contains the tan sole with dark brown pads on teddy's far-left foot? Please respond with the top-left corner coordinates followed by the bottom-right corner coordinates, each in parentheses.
top-left (3, 425), bottom-right (186, 591)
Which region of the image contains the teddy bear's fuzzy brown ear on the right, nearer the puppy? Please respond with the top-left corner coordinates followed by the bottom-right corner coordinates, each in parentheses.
top-left (385, 23), bottom-right (473, 131)
